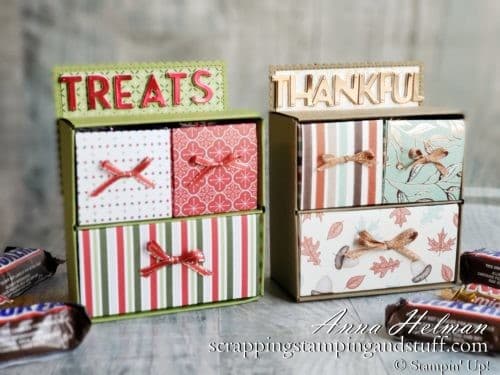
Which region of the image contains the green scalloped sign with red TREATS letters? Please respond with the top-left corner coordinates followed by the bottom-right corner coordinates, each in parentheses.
top-left (54, 62), bottom-right (225, 119)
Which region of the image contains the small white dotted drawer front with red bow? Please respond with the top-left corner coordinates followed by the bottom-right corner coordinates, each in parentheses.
top-left (75, 129), bottom-right (172, 225)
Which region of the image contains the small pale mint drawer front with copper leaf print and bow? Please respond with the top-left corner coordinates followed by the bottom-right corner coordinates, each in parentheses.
top-left (383, 119), bottom-right (465, 204)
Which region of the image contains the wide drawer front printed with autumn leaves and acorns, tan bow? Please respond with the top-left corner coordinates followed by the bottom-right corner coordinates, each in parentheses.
top-left (298, 204), bottom-right (459, 296)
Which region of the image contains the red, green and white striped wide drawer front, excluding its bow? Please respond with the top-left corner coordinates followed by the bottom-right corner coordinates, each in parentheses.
top-left (78, 214), bottom-right (260, 317)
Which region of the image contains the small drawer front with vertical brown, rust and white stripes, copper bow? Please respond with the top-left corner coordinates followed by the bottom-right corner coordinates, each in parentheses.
top-left (298, 120), bottom-right (384, 210)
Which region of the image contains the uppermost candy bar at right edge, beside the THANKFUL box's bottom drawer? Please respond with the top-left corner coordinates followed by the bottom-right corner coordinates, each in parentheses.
top-left (460, 249), bottom-right (500, 288)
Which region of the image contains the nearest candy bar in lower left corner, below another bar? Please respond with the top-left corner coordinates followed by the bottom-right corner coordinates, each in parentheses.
top-left (0, 302), bottom-right (91, 361)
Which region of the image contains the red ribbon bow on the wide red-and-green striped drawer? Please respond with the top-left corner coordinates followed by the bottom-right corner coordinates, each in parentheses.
top-left (140, 241), bottom-right (212, 277)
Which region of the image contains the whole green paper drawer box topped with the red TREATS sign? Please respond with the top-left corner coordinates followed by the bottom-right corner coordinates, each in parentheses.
top-left (54, 62), bottom-right (264, 321)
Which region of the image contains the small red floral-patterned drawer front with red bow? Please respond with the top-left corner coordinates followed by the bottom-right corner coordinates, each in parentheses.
top-left (172, 123), bottom-right (258, 216)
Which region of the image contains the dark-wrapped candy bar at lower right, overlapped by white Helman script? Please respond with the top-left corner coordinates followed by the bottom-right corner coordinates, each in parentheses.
top-left (385, 298), bottom-right (500, 352)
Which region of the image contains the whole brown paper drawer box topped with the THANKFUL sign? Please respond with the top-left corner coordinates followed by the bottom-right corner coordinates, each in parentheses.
top-left (269, 63), bottom-right (465, 301)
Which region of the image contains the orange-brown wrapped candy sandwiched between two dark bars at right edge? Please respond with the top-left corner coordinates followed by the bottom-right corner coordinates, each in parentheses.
top-left (441, 284), bottom-right (500, 309)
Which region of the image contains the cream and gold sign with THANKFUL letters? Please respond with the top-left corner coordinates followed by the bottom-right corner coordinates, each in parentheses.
top-left (270, 64), bottom-right (424, 112)
